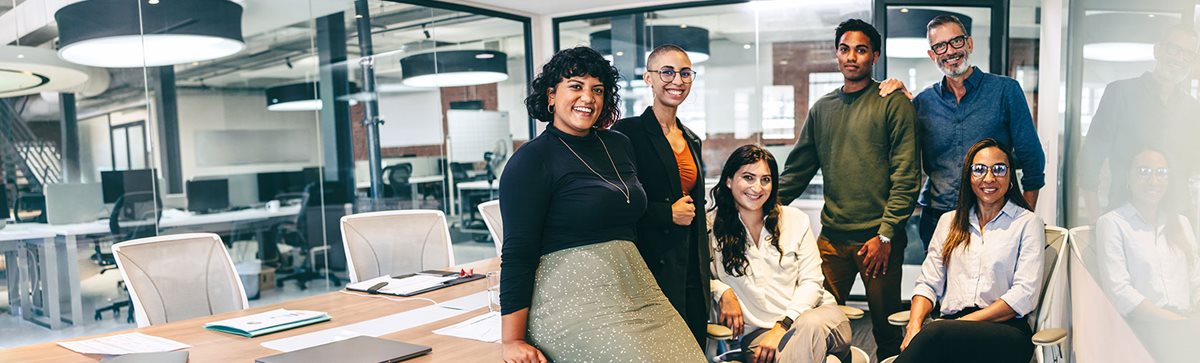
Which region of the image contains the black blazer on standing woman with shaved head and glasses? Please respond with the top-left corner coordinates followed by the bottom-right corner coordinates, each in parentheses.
top-left (612, 107), bottom-right (712, 314)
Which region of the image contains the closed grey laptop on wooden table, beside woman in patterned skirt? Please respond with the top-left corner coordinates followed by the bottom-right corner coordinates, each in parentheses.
top-left (254, 337), bottom-right (433, 363)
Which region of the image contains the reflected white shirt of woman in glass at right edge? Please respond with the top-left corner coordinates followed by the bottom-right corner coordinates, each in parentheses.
top-left (1096, 204), bottom-right (1200, 315)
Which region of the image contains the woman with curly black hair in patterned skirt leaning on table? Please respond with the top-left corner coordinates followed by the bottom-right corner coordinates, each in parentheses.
top-left (500, 47), bottom-right (704, 362)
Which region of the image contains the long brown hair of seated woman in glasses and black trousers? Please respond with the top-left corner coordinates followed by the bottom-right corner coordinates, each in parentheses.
top-left (942, 138), bottom-right (1033, 264)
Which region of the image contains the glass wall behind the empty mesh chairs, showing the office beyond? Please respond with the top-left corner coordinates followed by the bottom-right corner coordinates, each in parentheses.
top-left (0, 0), bottom-right (530, 347)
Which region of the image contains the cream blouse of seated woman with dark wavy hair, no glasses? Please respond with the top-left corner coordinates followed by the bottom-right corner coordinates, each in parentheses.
top-left (708, 206), bottom-right (836, 332)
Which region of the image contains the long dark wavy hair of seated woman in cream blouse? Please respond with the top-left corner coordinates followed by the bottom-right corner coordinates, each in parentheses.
top-left (709, 144), bottom-right (784, 276)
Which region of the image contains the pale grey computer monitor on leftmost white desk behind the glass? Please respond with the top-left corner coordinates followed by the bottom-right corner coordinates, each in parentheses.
top-left (43, 183), bottom-right (104, 225)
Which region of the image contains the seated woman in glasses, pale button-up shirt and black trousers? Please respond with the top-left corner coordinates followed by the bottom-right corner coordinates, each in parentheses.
top-left (895, 138), bottom-right (1045, 363)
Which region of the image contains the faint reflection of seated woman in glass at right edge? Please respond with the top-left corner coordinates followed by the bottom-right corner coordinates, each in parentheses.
top-left (1096, 149), bottom-right (1200, 362)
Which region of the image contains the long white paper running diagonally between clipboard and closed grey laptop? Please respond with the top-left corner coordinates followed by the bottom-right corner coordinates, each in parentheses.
top-left (263, 291), bottom-right (487, 352)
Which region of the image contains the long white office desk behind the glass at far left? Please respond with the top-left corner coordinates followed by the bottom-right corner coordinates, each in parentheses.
top-left (12, 206), bottom-right (300, 329)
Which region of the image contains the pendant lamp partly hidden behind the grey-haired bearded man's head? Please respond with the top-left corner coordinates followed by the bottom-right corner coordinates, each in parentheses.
top-left (883, 7), bottom-right (972, 59)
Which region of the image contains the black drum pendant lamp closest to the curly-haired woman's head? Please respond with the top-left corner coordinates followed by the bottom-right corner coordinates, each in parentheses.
top-left (400, 50), bottom-right (509, 88)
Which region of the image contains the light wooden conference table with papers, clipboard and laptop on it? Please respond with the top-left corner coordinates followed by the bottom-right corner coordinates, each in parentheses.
top-left (0, 258), bottom-right (500, 362)
